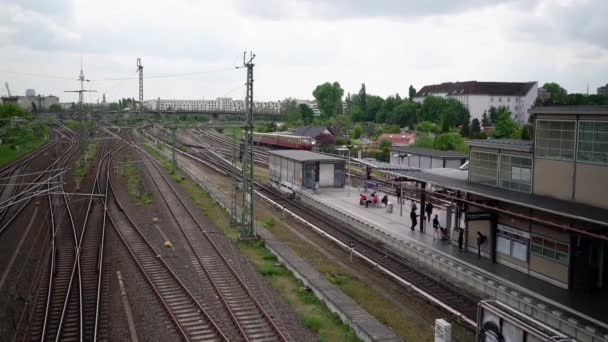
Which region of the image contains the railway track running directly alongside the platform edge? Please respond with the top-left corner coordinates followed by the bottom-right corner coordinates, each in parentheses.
top-left (166, 134), bottom-right (479, 326)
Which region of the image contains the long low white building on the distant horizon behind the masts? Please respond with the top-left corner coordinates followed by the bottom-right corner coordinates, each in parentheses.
top-left (144, 97), bottom-right (281, 113)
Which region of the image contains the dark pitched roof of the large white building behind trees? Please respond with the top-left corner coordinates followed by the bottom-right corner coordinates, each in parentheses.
top-left (416, 81), bottom-right (536, 97)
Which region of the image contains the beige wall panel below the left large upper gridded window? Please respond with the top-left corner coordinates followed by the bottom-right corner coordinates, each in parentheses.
top-left (532, 158), bottom-right (574, 200)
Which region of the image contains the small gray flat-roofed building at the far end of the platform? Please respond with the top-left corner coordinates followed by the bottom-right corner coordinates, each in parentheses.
top-left (268, 150), bottom-right (346, 191)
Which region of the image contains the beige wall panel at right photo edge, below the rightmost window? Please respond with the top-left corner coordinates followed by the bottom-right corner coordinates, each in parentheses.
top-left (574, 163), bottom-right (608, 209)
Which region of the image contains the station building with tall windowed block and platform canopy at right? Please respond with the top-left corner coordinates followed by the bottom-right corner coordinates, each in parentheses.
top-left (394, 106), bottom-right (608, 292)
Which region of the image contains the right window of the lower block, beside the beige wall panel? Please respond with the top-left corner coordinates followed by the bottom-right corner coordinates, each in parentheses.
top-left (500, 154), bottom-right (532, 192)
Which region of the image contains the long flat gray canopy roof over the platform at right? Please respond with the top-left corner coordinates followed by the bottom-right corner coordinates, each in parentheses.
top-left (392, 170), bottom-right (608, 226)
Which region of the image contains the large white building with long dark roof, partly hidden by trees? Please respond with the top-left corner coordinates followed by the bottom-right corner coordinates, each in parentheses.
top-left (414, 81), bottom-right (538, 123)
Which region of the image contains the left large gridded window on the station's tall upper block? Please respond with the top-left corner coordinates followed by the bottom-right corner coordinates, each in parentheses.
top-left (534, 120), bottom-right (576, 160)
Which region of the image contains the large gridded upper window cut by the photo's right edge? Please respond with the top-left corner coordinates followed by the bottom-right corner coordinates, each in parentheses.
top-left (576, 121), bottom-right (608, 165)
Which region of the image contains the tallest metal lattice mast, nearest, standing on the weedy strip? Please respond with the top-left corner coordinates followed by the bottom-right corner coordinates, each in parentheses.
top-left (241, 52), bottom-right (255, 239)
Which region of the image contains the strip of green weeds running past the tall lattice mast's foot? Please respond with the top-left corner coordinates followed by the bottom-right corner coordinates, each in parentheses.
top-left (146, 145), bottom-right (359, 341)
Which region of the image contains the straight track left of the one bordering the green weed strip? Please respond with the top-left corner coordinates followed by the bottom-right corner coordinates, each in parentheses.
top-left (106, 140), bottom-right (228, 341)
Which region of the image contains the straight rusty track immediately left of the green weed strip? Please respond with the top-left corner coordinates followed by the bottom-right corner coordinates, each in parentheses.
top-left (135, 144), bottom-right (287, 341)
